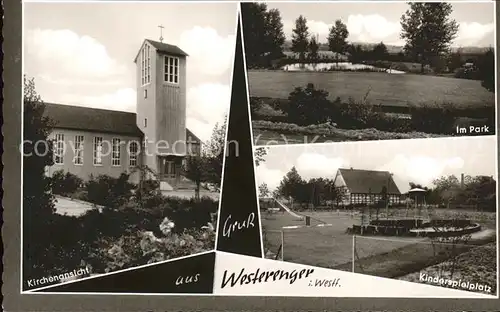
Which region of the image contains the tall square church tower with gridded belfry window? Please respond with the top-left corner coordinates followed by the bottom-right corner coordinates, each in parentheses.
top-left (134, 39), bottom-right (188, 190)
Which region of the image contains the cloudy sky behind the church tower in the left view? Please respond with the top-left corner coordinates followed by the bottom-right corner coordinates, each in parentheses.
top-left (24, 2), bottom-right (237, 141)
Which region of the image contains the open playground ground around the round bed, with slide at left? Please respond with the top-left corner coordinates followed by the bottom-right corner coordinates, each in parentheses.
top-left (261, 200), bottom-right (496, 288)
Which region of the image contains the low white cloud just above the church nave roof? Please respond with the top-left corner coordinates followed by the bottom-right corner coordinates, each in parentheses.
top-left (56, 88), bottom-right (137, 113)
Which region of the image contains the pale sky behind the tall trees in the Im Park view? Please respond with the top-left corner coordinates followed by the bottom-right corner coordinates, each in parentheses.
top-left (274, 1), bottom-right (495, 47)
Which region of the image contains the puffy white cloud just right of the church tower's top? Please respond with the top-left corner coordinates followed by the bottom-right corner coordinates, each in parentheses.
top-left (180, 26), bottom-right (236, 76)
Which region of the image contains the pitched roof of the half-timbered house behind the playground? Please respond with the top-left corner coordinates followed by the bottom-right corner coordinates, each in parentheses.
top-left (339, 169), bottom-right (401, 195)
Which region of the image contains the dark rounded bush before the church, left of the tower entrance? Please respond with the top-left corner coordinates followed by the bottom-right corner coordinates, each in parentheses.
top-left (85, 173), bottom-right (134, 208)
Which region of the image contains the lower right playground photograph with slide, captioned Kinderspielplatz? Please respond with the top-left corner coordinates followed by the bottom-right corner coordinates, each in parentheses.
top-left (255, 136), bottom-right (497, 296)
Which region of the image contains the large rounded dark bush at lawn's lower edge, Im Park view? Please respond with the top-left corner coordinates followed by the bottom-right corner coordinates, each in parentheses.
top-left (286, 83), bottom-right (332, 125)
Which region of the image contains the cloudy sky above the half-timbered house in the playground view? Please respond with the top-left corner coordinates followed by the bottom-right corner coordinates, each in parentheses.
top-left (255, 136), bottom-right (497, 193)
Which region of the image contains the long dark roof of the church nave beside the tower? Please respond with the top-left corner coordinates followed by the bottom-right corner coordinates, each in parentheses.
top-left (44, 103), bottom-right (199, 140)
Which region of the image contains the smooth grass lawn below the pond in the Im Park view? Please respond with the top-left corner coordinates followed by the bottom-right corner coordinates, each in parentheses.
top-left (248, 70), bottom-right (495, 107)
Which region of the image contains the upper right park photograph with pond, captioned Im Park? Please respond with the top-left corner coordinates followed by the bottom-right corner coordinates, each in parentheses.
top-left (241, 1), bottom-right (496, 146)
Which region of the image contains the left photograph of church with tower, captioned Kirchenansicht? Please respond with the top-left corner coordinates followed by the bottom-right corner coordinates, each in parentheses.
top-left (21, 2), bottom-right (238, 291)
